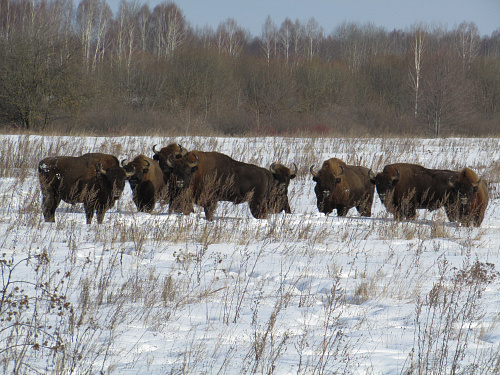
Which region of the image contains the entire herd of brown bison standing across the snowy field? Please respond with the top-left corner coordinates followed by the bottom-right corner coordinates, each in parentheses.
top-left (38, 144), bottom-right (488, 226)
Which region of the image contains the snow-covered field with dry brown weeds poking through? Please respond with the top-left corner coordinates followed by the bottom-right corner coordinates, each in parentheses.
top-left (0, 135), bottom-right (500, 374)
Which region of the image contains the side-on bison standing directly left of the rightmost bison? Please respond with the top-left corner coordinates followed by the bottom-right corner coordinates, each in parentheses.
top-left (369, 163), bottom-right (458, 220)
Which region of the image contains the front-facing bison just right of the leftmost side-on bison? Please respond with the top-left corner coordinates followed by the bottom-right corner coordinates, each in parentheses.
top-left (122, 155), bottom-right (165, 212)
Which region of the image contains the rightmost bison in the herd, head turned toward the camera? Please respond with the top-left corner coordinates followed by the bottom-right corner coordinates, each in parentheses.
top-left (446, 168), bottom-right (488, 227)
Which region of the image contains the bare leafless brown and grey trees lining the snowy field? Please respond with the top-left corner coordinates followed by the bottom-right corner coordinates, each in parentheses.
top-left (0, 0), bottom-right (500, 137)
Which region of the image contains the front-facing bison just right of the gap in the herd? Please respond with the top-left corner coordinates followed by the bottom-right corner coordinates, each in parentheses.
top-left (310, 158), bottom-right (375, 216)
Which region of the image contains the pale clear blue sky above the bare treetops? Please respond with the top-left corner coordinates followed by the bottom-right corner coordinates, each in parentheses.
top-left (107, 0), bottom-right (500, 36)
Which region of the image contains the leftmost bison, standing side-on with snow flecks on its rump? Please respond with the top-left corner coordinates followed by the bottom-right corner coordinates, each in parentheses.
top-left (38, 153), bottom-right (134, 224)
